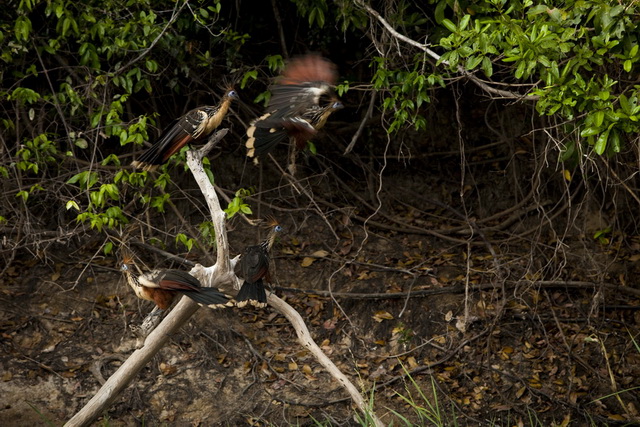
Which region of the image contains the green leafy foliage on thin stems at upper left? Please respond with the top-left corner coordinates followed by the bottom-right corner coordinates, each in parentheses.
top-left (0, 0), bottom-right (242, 254)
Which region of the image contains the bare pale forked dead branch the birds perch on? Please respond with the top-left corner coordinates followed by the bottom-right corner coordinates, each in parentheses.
top-left (65, 129), bottom-right (384, 426)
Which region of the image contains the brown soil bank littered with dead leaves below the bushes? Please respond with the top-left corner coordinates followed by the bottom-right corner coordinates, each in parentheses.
top-left (0, 133), bottom-right (640, 426)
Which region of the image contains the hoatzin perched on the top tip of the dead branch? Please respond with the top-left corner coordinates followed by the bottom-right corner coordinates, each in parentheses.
top-left (131, 90), bottom-right (238, 171)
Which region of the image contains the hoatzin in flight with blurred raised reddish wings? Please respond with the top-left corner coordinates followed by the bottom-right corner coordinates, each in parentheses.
top-left (245, 54), bottom-right (343, 161)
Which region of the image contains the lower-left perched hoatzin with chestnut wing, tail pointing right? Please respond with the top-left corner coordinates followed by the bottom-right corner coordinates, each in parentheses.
top-left (121, 258), bottom-right (233, 310)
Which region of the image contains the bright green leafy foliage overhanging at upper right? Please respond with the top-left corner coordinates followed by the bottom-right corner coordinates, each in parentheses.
top-left (337, 0), bottom-right (640, 161)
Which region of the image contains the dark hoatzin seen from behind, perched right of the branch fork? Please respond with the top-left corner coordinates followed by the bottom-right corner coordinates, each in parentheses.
top-left (235, 220), bottom-right (282, 308)
